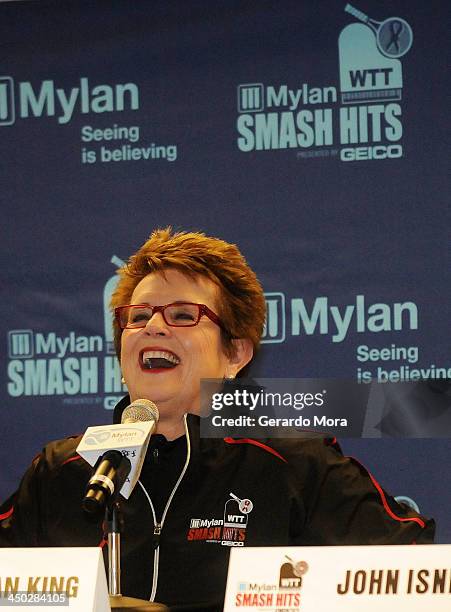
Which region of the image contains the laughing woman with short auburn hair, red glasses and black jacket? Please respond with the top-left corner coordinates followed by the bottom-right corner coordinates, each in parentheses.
top-left (0, 228), bottom-right (434, 610)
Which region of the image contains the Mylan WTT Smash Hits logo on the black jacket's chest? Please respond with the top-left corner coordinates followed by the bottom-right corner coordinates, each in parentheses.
top-left (187, 493), bottom-right (254, 546)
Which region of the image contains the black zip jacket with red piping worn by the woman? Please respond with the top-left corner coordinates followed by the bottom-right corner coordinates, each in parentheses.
top-left (0, 401), bottom-right (434, 610)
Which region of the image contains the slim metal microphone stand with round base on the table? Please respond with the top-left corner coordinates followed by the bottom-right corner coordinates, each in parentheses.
top-left (105, 496), bottom-right (169, 612)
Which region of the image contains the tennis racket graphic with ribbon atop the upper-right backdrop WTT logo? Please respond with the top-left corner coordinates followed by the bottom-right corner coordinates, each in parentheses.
top-left (345, 4), bottom-right (413, 58)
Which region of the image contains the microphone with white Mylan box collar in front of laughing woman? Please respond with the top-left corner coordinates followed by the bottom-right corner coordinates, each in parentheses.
top-left (77, 399), bottom-right (159, 514)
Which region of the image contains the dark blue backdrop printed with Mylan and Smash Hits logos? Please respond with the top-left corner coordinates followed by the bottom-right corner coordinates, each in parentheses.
top-left (0, 0), bottom-right (451, 542)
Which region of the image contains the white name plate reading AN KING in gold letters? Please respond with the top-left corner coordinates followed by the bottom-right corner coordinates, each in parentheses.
top-left (0, 547), bottom-right (111, 612)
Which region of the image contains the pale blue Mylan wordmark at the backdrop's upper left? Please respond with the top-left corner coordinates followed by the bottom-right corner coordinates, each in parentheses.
top-left (0, 76), bottom-right (139, 125)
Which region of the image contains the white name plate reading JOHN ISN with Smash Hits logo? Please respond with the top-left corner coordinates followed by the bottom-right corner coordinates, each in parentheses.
top-left (224, 544), bottom-right (451, 612)
